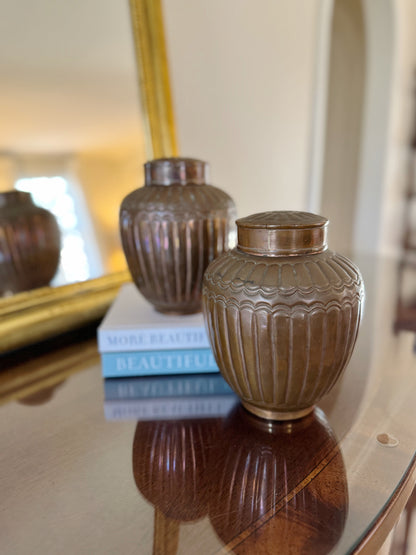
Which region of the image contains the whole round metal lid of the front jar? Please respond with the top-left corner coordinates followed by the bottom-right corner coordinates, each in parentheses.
top-left (236, 211), bottom-right (328, 256)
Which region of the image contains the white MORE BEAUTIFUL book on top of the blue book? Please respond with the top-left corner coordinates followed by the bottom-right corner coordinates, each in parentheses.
top-left (97, 283), bottom-right (210, 353)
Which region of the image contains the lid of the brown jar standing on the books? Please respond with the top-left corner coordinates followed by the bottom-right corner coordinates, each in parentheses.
top-left (144, 158), bottom-right (209, 186)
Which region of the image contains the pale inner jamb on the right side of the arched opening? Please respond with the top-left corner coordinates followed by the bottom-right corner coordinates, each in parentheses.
top-left (354, 0), bottom-right (397, 252)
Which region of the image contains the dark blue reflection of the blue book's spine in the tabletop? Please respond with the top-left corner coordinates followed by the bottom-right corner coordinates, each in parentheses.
top-left (104, 374), bottom-right (232, 401)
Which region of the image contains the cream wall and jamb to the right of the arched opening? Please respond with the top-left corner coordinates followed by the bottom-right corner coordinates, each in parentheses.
top-left (355, 0), bottom-right (416, 256)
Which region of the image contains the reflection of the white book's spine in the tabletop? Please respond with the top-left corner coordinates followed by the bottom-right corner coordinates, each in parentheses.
top-left (104, 395), bottom-right (238, 420)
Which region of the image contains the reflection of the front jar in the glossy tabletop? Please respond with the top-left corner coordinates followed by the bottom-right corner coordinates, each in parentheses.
top-left (209, 405), bottom-right (348, 555)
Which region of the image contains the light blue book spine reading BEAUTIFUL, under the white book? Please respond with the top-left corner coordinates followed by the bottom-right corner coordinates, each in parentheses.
top-left (101, 349), bottom-right (219, 378)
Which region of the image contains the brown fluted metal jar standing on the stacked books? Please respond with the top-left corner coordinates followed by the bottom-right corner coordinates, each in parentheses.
top-left (120, 158), bottom-right (235, 314)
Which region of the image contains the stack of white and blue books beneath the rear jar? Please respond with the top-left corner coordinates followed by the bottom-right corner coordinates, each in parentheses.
top-left (98, 283), bottom-right (219, 378)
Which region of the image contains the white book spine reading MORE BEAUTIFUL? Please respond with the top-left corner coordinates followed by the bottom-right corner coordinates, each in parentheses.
top-left (97, 326), bottom-right (210, 353)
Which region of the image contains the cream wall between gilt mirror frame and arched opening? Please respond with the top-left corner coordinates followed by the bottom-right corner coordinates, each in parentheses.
top-left (163, 0), bottom-right (326, 222)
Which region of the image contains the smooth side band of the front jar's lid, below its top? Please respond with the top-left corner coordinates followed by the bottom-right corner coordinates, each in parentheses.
top-left (237, 225), bottom-right (328, 256)
